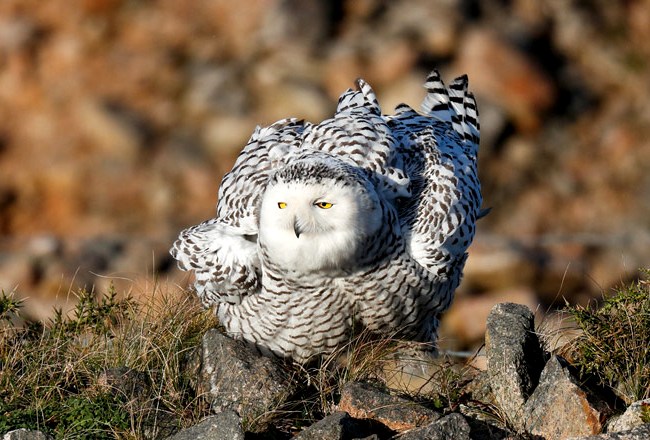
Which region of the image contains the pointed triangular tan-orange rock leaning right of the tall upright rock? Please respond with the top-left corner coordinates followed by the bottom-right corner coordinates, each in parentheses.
top-left (524, 356), bottom-right (611, 438)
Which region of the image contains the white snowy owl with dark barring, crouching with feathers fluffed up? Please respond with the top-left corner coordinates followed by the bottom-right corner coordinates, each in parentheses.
top-left (171, 71), bottom-right (482, 362)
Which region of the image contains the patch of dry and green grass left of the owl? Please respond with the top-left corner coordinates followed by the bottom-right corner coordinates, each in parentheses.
top-left (0, 289), bottom-right (216, 439)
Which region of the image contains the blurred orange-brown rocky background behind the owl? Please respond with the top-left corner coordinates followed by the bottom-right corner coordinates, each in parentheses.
top-left (0, 0), bottom-right (650, 349)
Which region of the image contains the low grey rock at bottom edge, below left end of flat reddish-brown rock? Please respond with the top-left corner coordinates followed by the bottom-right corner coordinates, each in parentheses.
top-left (294, 411), bottom-right (392, 440)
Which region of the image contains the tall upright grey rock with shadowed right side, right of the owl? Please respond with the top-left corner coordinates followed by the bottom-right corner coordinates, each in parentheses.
top-left (485, 303), bottom-right (544, 430)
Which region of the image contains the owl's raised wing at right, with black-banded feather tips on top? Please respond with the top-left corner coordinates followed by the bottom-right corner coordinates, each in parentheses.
top-left (388, 71), bottom-right (482, 278)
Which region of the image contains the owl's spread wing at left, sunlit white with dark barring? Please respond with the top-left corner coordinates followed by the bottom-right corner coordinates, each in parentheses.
top-left (171, 119), bottom-right (309, 305)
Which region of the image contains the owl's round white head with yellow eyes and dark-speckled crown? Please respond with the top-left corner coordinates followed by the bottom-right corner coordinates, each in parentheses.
top-left (259, 154), bottom-right (381, 273)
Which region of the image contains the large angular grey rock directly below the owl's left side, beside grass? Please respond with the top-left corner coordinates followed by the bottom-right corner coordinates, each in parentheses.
top-left (190, 329), bottom-right (296, 430)
